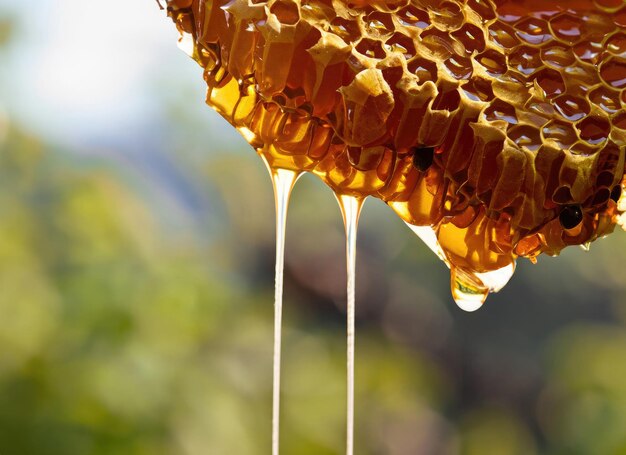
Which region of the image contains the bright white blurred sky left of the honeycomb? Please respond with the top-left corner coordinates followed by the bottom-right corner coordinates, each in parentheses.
top-left (0, 0), bottom-right (235, 151)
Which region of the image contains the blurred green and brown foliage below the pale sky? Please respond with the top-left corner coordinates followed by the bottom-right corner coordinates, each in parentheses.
top-left (0, 109), bottom-right (626, 455)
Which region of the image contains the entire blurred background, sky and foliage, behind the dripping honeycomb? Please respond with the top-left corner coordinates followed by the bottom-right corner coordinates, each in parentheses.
top-left (0, 0), bottom-right (626, 455)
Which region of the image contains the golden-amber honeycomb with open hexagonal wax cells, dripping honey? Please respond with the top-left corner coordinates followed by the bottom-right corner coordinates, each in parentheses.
top-left (162, 0), bottom-right (626, 306)
